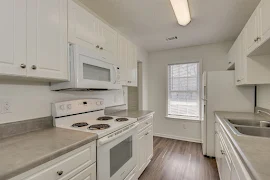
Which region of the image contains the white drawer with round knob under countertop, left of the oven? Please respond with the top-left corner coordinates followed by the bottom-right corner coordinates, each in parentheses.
top-left (26, 142), bottom-right (96, 180)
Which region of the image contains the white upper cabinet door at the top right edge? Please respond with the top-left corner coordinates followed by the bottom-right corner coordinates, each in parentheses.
top-left (258, 0), bottom-right (270, 42)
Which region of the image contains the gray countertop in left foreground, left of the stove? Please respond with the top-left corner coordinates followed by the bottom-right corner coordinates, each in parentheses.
top-left (0, 128), bottom-right (97, 179)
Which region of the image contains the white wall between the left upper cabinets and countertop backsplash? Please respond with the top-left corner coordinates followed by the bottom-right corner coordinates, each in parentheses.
top-left (0, 80), bottom-right (127, 123)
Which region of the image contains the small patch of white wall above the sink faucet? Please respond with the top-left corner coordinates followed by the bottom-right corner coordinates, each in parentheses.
top-left (257, 85), bottom-right (270, 109)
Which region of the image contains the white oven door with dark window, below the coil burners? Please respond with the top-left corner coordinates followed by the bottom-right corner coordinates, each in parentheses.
top-left (97, 125), bottom-right (137, 180)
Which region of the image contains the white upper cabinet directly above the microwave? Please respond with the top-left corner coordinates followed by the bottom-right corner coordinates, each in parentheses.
top-left (68, 0), bottom-right (117, 64)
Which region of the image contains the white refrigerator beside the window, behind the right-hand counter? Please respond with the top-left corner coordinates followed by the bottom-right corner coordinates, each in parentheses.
top-left (201, 71), bottom-right (255, 157)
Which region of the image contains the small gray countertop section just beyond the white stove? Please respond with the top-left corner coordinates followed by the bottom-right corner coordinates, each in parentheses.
top-left (109, 110), bottom-right (154, 119)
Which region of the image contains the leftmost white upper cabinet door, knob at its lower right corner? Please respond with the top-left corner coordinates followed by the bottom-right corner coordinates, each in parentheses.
top-left (0, 0), bottom-right (26, 76)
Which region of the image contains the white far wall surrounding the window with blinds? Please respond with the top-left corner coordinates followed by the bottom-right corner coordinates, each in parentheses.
top-left (147, 42), bottom-right (233, 142)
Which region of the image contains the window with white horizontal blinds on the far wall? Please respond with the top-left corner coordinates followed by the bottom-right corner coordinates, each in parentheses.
top-left (168, 63), bottom-right (200, 120)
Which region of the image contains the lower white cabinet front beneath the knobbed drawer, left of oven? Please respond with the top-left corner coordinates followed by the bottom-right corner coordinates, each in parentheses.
top-left (70, 163), bottom-right (97, 180)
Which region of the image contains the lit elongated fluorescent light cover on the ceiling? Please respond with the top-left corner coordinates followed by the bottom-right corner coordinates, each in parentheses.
top-left (171, 0), bottom-right (191, 26)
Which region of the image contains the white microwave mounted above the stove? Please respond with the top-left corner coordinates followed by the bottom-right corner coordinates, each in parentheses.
top-left (74, 45), bottom-right (122, 89)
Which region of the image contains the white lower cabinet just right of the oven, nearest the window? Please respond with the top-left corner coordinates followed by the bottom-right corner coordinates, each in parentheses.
top-left (136, 116), bottom-right (153, 178)
